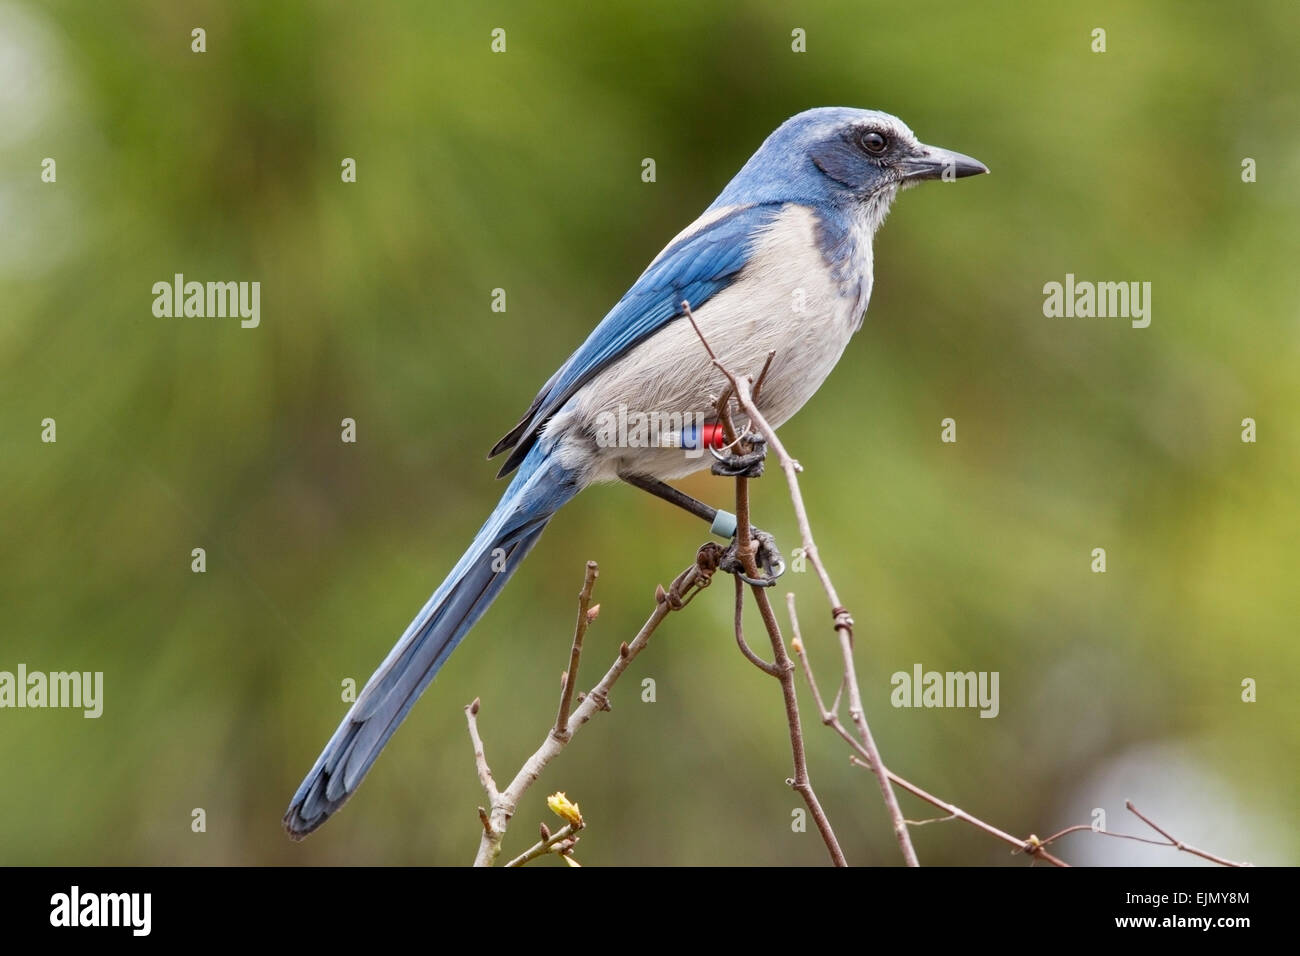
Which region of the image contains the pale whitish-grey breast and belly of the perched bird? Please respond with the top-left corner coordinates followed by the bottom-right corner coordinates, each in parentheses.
top-left (543, 204), bottom-right (872, 480)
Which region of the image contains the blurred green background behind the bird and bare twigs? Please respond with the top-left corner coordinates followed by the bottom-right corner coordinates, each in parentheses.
top-left (0, 0), bottom-right (1300, 865)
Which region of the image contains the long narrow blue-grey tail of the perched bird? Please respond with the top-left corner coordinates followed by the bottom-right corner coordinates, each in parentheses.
top-left (291, 445), bottom-right (582, 840)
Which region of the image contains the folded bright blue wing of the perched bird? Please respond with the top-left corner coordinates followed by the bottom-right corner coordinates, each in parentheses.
top-left (488, 203), bottom-right (781, 477)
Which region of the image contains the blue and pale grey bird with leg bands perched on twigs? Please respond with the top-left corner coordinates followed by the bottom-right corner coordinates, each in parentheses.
top-left (283, 107), bottom-right (988, 839)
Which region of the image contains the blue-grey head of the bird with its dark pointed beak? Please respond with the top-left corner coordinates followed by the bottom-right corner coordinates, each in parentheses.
top-left (714, 107), bottom-right (988, 217)
